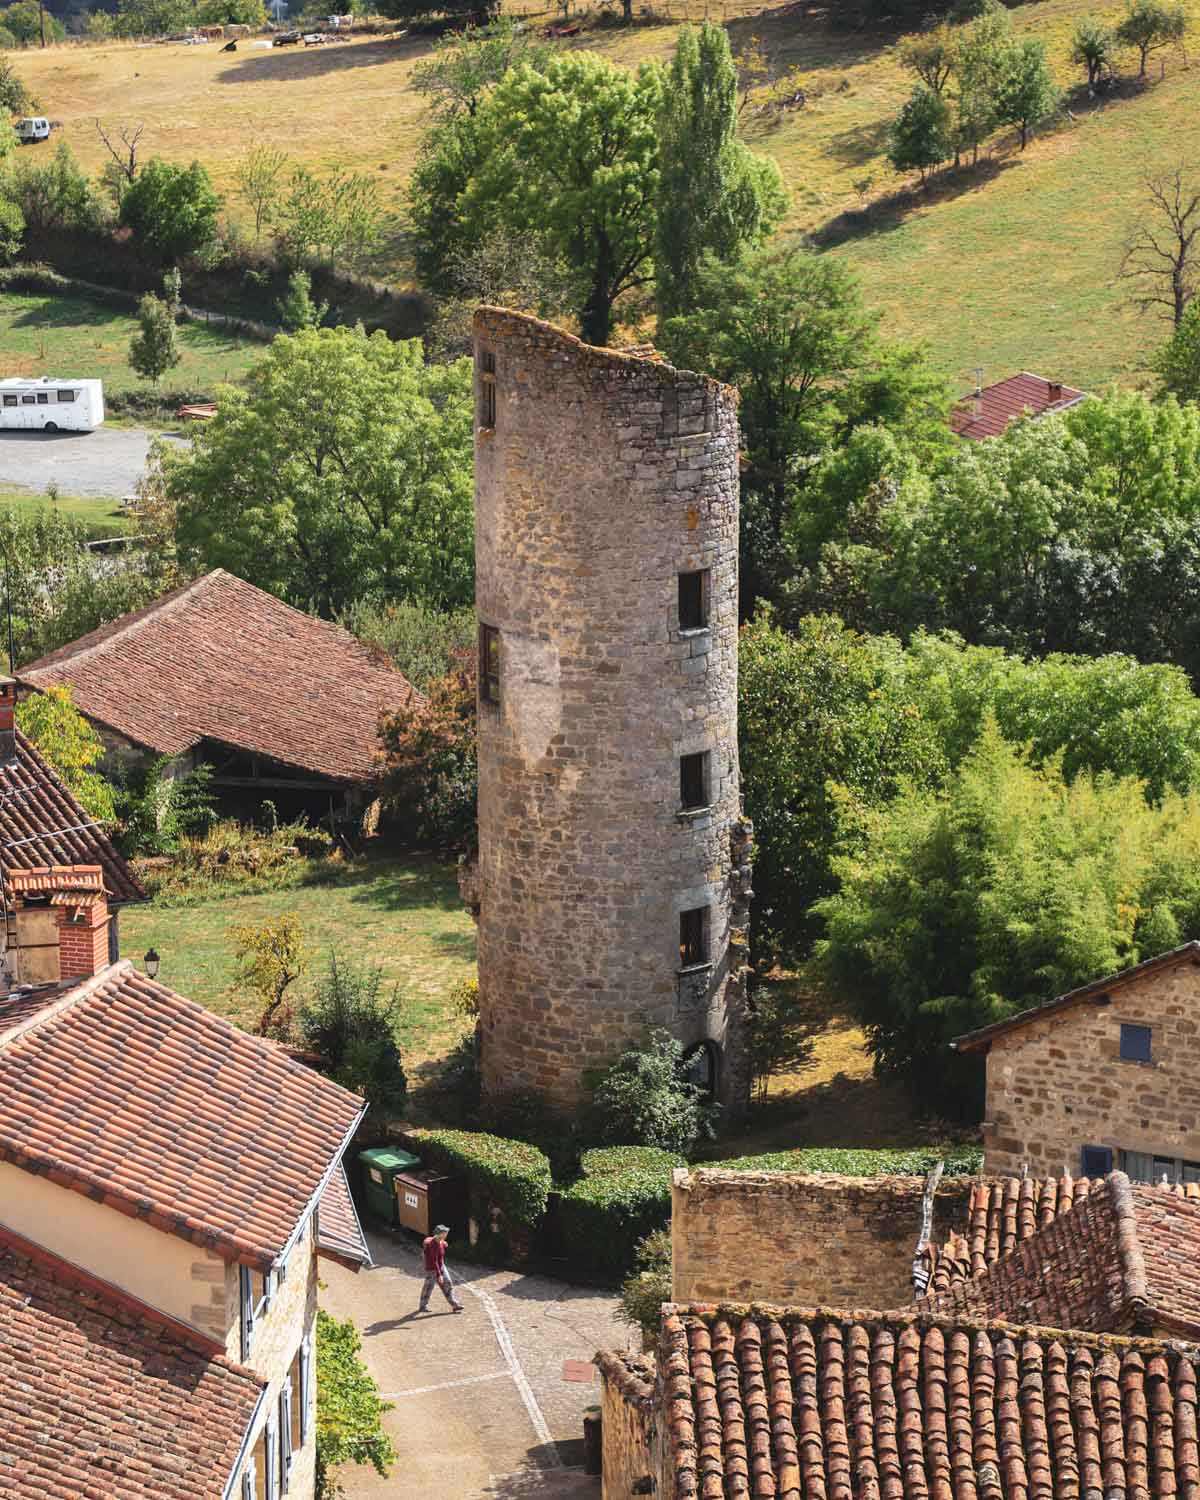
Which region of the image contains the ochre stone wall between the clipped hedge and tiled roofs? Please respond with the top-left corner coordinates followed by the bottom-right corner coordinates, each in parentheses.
top-left (671, 1169), bottom-right (972, 1310)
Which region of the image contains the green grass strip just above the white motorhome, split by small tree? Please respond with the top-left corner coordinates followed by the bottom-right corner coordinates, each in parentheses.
top-left (0, 293), bottom-right (264, 392)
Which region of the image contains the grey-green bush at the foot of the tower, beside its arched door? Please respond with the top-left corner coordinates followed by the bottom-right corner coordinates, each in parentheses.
top-left (591, 1031), bottom-right (717, 1155)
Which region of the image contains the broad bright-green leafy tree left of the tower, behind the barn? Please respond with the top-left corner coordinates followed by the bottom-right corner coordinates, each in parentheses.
top-left (164, 329), bottom-right (474, 617)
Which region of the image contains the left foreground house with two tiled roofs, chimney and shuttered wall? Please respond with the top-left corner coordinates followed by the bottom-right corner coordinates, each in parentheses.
top-left (0, 866), bottom-right (369, 1500)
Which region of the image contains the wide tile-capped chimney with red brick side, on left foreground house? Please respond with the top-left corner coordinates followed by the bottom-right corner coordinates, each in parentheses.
top-left (9, 864), bottom-right (110, 984)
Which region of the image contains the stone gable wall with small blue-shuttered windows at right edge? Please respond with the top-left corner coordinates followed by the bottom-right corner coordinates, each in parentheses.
top-left (984, 956), bottom-right (1200, 1178)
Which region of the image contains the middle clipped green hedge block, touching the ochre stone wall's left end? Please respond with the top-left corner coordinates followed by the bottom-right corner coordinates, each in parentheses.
top-left (560, 1146), bottom-right (687, 1275)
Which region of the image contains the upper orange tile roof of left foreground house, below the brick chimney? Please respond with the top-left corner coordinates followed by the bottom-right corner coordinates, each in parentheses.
top-left (0, 963), bottom-right (363, 1269)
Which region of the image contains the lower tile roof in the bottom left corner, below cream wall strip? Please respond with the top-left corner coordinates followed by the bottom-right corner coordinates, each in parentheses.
top-left (0, 1230), bottom-right (263, 1500)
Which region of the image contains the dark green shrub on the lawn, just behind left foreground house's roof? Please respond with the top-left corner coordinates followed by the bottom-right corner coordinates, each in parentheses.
top-left (296, 953), bottom-right (408, 1119)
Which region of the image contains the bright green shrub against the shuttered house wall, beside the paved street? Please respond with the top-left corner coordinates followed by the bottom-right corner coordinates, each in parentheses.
top-left (317, 1308), bottom-right (396, 1500)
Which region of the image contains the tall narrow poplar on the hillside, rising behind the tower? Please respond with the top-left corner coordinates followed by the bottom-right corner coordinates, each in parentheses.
top-left (654, 21), bottom-right (786, 323)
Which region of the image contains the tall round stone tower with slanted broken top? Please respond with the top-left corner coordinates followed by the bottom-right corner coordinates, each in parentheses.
top-left (474, 308), bottom-right (750, 1110)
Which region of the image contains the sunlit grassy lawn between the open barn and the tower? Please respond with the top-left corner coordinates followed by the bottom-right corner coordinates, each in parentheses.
top-left (120, 855), bottom-right (476, 1104)
